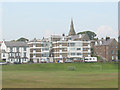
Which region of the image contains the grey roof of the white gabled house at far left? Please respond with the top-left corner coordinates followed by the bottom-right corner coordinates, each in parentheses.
top-left (5, 41), bottom-right (29, 47)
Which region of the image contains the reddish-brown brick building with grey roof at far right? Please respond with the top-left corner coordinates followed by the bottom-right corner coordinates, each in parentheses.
top-left (94, 37), bottom-right (118, 61)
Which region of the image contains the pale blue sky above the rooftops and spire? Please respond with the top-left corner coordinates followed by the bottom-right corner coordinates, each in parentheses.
top-left (0, 2), bottom-right (118, 40)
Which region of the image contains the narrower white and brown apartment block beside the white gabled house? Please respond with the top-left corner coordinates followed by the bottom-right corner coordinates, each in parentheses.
top-left (28, 39), bottom-right (51, 63)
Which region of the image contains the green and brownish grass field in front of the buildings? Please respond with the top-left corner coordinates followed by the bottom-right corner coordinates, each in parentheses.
top-left (2, 63), bottom-right (118, 88)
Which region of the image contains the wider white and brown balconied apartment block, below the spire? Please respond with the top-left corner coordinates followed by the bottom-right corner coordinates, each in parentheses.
top-left (53, 37), bottom-right (91, 62)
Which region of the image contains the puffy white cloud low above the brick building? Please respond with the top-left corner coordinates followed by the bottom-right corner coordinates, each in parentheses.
top-left (96, 25), bottom-right (118, 38)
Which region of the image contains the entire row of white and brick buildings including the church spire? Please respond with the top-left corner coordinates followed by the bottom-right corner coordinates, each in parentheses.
top-left (0, 20), bottom-right (118, 63)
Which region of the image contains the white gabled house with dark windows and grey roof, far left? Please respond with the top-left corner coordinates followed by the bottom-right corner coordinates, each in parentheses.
top-left (1, 41), bottom-right (30, 63)
